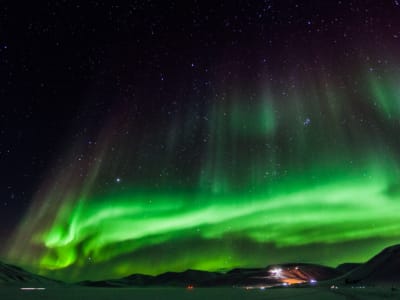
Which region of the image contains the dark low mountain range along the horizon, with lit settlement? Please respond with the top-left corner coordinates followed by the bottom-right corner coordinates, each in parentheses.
top-left (0, 245), bottom-right (400, 287)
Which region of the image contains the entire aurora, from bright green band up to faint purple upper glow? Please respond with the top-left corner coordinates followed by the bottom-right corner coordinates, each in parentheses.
top-left (3, 1), bottom-right (400, 281)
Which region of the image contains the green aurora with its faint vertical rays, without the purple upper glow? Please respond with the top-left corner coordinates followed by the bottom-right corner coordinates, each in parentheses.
top-left (7, 65), bottom-right (400, 281)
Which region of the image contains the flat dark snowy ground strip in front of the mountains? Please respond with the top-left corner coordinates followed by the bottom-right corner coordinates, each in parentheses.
top-left (0, 287), bottom-right (400, 300)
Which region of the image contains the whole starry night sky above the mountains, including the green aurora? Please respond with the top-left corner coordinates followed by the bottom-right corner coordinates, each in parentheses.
top-left (0, 0), bottom-right (400, 281)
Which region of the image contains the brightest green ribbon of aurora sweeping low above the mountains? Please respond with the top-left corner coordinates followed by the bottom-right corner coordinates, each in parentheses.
top-left (43, 175), bottom-right (400, 267)
